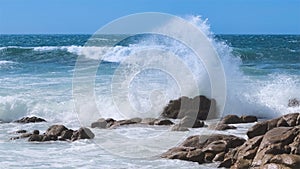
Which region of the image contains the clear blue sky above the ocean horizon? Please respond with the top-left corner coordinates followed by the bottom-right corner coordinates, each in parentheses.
top-left (0, 0), bottom-right (300, 34)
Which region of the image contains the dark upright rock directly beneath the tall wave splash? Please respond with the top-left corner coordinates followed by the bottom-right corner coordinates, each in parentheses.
top-left (161, 96), bottom-right (216, 120)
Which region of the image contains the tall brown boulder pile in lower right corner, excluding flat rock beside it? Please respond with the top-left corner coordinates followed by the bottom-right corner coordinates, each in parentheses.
top-left (220, 113), bottom-right (300, 169)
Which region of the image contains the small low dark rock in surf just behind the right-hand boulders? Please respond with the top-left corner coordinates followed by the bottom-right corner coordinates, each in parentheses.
top-left (221, 115), bottom-right (257, 124)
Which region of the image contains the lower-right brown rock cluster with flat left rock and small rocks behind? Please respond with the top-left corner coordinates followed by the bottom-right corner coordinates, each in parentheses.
top-left (161, 113), bottom-right (300, 169)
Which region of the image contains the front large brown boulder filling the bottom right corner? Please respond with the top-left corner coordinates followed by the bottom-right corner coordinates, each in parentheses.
top-left (220, 125), bottom-right (300, 169)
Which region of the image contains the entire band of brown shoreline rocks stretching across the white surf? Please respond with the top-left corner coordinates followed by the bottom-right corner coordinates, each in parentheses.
top-left (7, 96), bottom-right (300, 169)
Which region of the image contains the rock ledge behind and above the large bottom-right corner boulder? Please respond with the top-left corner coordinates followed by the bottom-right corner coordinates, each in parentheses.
top-left (247, 113), bottom-right (300, 138)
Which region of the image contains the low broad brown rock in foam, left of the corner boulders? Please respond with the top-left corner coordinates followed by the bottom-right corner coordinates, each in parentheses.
top-left (162, 134), bottom-right (245, 164)
